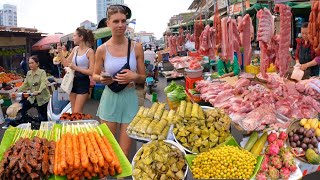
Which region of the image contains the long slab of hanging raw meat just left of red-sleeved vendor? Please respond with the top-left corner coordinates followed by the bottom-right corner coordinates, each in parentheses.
top-left (275, 4), bottom-right (292, 77)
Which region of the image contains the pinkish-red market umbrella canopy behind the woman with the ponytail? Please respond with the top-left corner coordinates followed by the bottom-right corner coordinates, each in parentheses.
top-left (32, 34), bottom-right (64, 51)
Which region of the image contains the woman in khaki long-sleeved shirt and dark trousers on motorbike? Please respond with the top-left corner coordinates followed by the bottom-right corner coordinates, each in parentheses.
top-left (18, 56), bottom-right (50, 121)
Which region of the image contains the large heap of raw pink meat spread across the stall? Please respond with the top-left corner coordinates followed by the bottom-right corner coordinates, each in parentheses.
top-left (196, 76), bottom-right (320, 131)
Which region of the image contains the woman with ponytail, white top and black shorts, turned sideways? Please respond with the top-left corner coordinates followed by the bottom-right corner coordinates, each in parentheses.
top-left (58, 28), bottom-right (95, 113)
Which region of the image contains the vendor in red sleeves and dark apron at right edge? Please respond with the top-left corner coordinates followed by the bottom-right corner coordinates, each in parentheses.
top-left (295, 23), bottom-right (320, 79)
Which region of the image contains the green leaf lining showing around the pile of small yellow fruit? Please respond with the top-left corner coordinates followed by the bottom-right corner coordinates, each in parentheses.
top-left (185, 136), bottom-right (264, 179)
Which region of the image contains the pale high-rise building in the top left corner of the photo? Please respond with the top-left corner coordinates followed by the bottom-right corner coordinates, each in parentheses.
top-left (0, 4), bottom-right (18, 27)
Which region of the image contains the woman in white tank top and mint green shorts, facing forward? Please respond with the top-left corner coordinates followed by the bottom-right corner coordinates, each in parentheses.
top-left (93, 5), bottom-right (146, 157)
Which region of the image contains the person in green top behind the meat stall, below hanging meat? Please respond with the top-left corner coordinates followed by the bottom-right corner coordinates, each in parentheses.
top-left (217, 51), bottom-right (240, 78)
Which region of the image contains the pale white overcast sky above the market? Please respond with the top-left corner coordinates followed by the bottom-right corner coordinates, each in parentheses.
top-left (0, 0), bottom-right (193, 38)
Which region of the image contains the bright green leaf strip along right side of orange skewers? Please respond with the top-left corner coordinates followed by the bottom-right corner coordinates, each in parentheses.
top-left (99, 124), bottom-right (132, 178)
